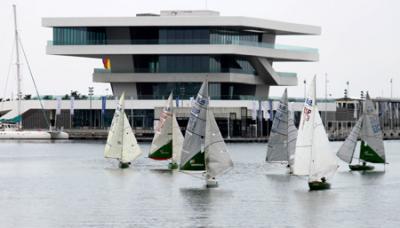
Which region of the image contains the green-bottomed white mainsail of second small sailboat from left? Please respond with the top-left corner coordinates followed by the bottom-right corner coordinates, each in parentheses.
top-left (149, 93), bottom-right (173, 160)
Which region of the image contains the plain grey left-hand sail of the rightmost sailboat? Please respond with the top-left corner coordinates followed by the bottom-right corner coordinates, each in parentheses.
top-left (336, 117), bottom-right (363, 164)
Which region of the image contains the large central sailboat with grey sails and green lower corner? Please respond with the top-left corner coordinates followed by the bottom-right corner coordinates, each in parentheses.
top-left (179, 82), bottom-right (233, 187)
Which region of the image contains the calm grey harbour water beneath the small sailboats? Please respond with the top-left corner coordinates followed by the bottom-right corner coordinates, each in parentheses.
top-left (0, 141), bottom-right (400, 227)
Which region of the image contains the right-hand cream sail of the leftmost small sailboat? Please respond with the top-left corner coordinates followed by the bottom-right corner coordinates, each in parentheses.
top-left (121, 113), bottom-right (142, 163)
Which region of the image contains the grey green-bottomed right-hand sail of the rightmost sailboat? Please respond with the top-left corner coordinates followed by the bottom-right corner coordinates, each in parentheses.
top-left (360, 94), bottom-right (386, 163)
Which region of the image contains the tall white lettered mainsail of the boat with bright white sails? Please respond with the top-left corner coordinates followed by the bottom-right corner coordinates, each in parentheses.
top-left (293, 77), bottom-right (316, 175)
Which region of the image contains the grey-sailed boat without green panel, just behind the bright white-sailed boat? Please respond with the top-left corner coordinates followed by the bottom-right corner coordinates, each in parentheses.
top-left (266, 89), bottom-right (297, 173)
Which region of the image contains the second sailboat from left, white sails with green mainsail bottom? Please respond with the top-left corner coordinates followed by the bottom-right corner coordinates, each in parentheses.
top-left (149, 93), bottom-right (183, 169)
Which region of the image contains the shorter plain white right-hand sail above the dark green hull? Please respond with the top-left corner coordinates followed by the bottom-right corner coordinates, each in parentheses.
top-left (309, 105), bottom-right (338, 181)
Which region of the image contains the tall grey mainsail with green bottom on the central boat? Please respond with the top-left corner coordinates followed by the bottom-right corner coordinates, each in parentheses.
top-left (180, 82), bottom-right (209, 171)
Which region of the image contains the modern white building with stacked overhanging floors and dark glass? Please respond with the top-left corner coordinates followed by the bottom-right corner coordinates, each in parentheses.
top-left (42, 11), bottom-right (321, 135)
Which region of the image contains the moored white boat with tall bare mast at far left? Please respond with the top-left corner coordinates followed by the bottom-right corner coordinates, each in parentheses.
top-left (0, 5), bottom-right (69, 139)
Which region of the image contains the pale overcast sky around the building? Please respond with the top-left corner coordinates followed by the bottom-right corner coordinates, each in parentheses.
top-left (0, 0), bottom-right (400, 97)
